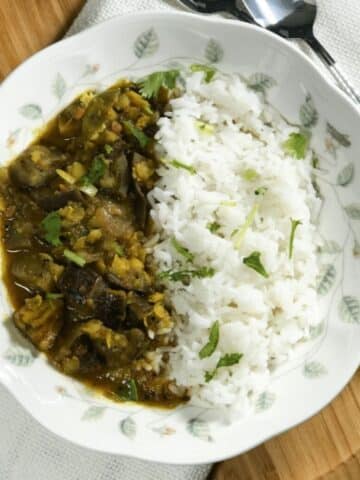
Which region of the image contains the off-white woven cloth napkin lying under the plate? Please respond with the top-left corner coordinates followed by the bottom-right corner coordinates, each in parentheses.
top-left (0, 0), bottom-right (360, 480)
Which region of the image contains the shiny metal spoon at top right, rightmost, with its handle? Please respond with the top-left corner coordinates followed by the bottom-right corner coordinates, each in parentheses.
top-left (243, 0), bottom-right (360, 104)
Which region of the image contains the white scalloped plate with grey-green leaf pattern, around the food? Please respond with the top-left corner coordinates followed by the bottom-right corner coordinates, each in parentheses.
top-left (0, 9), bottom-right (360, 463)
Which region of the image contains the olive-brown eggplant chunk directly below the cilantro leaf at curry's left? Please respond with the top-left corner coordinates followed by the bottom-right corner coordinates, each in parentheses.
top-left (11, 252), bottom-right (63, 292)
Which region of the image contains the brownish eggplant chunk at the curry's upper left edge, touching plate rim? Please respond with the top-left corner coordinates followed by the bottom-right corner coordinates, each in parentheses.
top-left (9, 145), bottom-right (65, 188)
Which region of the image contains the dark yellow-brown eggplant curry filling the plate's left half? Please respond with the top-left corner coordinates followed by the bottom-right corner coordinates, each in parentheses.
top-left (0, 80), bottom-right (183, 404)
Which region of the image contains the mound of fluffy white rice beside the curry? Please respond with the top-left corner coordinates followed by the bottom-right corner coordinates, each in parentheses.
top-left (149, 72), bottom-right (319, 415)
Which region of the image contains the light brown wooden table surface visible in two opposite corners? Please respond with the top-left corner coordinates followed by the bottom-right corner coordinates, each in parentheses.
top-left (0, 0), bottom-right (360, 480)
